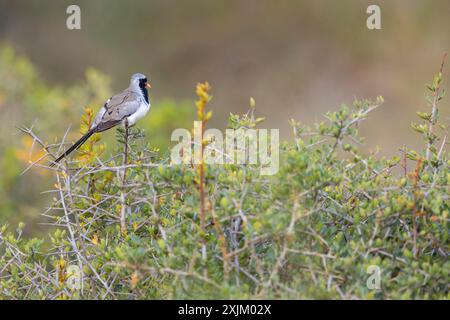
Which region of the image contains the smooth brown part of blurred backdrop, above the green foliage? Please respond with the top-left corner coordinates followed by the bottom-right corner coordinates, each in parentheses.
top-left (0, 0), bottom-right (450, 149)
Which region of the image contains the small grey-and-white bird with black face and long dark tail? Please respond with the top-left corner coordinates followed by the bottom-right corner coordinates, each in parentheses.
top-left (50, 73), bottom-right (151, 166)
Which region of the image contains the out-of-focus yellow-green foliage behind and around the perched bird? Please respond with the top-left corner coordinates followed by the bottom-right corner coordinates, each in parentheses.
top-left (0, 45), bottom-right (193, 228)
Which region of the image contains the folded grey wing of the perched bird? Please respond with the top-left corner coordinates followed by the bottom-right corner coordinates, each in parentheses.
top-left (92, 90), bottom-right (140, 132)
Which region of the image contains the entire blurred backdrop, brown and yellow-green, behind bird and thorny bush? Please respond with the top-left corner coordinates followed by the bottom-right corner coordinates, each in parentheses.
top-left (0, 0), bottom-right (450, 232)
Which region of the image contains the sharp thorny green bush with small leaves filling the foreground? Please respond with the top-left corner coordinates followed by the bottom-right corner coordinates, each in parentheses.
top-left (0, 50), bottom-right (450, 299)
